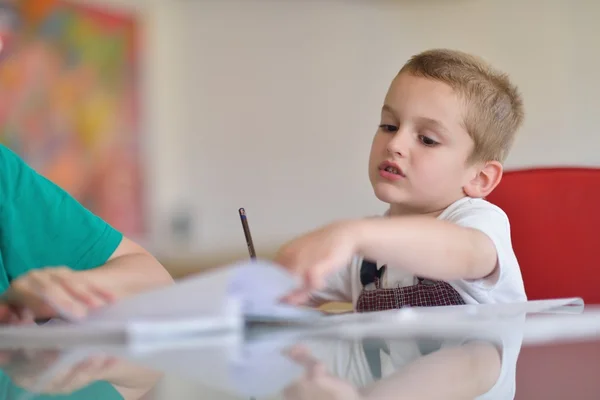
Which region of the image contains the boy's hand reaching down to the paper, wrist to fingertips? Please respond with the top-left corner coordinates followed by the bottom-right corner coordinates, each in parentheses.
top-left (274, 221), bottom-right (359, 304)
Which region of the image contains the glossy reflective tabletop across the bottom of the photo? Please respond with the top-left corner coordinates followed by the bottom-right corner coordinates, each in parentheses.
top-left (0, 306), bottom-right (600, 400)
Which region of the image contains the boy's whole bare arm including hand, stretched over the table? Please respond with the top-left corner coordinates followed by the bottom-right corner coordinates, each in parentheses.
top-left (275, 216), bottom-right (498, 301)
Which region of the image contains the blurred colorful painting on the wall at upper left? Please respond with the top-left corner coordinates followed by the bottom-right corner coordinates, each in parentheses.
top-left (0, 0), bottom-right (144, 236)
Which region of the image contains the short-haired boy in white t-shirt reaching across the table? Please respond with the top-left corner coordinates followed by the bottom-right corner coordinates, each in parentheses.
top-left (275, 49), bottom-right (526, 311)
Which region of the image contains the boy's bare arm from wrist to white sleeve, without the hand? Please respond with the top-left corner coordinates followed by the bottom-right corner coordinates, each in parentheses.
top-left (352, 216), bottom-right (498, 280)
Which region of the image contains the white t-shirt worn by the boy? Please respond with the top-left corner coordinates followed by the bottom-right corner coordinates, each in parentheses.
top-left (310, 197), bottom-right (527, 307)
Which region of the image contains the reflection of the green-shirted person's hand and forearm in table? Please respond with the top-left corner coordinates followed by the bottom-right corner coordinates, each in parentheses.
top-left (0, 350), bottom-right (160, 400)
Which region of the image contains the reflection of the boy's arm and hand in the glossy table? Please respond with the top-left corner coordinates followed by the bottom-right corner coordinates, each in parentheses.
top-left (284, 342), bottom-right (502, 400)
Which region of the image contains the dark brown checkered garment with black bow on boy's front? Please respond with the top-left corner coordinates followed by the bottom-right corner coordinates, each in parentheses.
top-left (356, 260), bottom-right (465, 312)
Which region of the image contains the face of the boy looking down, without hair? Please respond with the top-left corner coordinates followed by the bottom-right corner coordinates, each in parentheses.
top-left (369, 73), bottom-right (476, 215)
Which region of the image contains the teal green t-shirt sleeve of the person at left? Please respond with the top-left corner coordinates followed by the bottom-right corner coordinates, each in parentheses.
top-left (0, 146), bottom-right (123, 279)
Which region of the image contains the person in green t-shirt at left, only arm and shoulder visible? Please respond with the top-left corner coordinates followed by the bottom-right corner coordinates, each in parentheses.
top-left (0, 146), bottom-right (172, 324)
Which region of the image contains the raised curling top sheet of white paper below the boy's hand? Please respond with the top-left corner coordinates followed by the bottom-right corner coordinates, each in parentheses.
top-left (84, 260), bottom-right (315, 324)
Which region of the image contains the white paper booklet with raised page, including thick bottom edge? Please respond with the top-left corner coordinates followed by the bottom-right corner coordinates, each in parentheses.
top-left (79, 260), bottom-right (319, 340)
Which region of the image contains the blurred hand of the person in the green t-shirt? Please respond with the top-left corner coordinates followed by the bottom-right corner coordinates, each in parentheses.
top-left (0, 267), bottom-right (114, 323)
